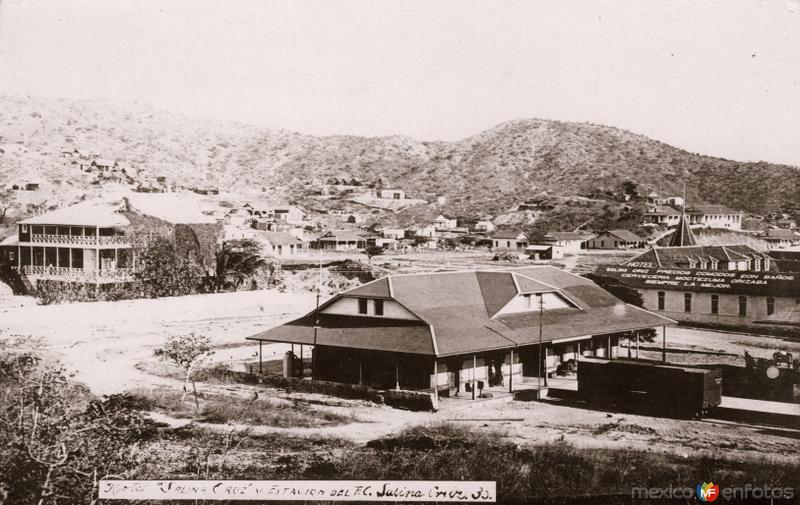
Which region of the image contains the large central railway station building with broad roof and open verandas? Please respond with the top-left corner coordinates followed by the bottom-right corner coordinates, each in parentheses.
top-left (248, 266), bottom-right (675, 396)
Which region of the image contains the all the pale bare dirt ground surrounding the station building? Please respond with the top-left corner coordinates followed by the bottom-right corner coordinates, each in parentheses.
top-left (0, 291), bottom-right (800, 461)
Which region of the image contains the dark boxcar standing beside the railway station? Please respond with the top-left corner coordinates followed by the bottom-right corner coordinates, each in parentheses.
top-left (578, 359), bottom-right (722, 418)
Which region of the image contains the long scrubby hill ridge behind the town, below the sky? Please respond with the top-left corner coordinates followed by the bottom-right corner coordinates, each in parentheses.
top-left (0, 96), bottom-right (800, 222)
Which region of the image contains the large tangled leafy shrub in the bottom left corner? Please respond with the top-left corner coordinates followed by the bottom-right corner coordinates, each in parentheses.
top-left (0, 354), bottom-right (150, 505)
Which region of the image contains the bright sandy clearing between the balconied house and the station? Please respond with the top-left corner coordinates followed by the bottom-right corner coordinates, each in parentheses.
top-left (0, 290), bottom-right (314, 394)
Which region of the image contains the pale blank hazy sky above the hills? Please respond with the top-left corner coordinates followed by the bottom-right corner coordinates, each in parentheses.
top-left (0, 0), bottom-right (800, 165)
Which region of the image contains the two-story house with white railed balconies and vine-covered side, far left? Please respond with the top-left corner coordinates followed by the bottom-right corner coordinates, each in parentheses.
top-left (0, 193), bottom-right (222, 294)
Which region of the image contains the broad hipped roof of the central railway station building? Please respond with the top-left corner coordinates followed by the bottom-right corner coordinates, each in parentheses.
top-left (248, 266), bottom-right (674, 357)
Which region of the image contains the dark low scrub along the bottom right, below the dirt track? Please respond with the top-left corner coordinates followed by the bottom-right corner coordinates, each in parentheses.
top-left (304, 424), bottom-right (800, 503)
